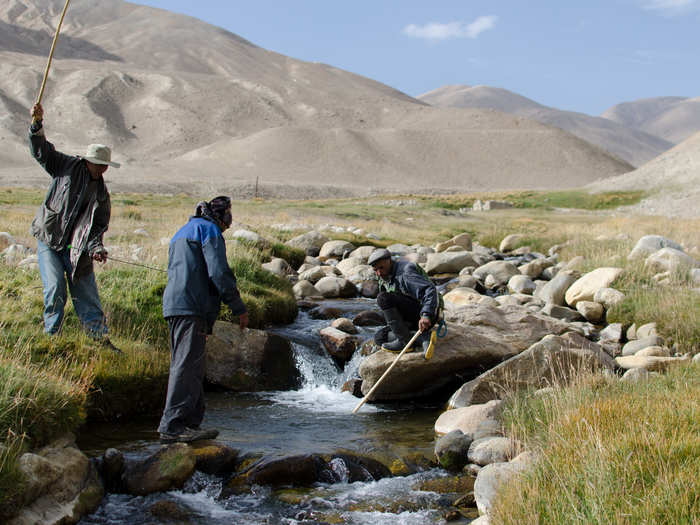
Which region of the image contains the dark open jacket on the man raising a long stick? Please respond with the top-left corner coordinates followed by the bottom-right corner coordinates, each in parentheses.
top-left (29, 125), bottom-right (112, 279)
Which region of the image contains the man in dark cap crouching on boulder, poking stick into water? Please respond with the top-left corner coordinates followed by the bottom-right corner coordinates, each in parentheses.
top-left (367, 248), bottom-right (441, 360)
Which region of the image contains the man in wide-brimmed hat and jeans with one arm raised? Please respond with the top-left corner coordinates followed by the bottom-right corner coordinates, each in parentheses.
top-left (29, 104), bottom-right (121, 353)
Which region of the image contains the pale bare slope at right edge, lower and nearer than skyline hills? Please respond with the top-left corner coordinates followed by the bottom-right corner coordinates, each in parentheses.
top-left (588, 132), bottom-right (700, 217)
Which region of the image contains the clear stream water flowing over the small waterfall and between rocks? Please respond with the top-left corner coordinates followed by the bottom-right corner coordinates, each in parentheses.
top-left (80, 299), bottom-right (474, 525)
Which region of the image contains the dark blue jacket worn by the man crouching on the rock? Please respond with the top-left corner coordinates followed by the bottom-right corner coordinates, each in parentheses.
top-left (379, 260), bottom-right (440, 322)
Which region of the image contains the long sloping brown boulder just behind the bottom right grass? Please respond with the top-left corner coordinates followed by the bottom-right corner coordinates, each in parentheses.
top-left (448, 333), bottom-right (615, 407)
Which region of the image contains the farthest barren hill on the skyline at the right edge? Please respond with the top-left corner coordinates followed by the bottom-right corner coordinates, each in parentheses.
top-left (602, 97), bottom-right (700, 144)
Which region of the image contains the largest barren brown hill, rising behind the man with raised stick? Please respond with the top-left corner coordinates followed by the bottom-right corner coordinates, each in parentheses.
top-left (0, 0), bottom-right (632, 194)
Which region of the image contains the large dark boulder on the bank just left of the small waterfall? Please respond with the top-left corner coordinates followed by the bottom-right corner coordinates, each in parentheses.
top-left (206, 321), bottom-right (300, 392)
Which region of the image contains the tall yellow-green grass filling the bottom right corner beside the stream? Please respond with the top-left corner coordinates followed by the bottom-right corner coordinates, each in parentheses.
top-left (491, 365), bottom-right (700, 525)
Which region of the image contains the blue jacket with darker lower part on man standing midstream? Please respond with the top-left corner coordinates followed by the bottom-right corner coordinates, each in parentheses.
top-left (163, 217), bottom-right (246, 333)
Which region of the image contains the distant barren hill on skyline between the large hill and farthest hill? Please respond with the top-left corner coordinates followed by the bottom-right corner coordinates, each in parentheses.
top-left (418, 85), bottom-right (675, 166)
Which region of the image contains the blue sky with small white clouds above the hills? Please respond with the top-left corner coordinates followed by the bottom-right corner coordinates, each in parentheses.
top-left (136, 0), bottom-right (700, 115)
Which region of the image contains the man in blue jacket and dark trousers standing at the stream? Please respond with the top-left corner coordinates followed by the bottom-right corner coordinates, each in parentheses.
top-left (158, 196), bottom-right (248, 443)
